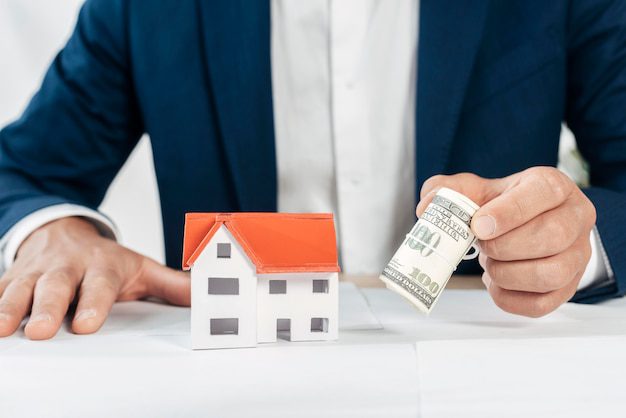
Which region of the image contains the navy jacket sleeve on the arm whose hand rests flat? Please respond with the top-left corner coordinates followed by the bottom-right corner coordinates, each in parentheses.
top-left (0, 0), bottom-right (143, 236)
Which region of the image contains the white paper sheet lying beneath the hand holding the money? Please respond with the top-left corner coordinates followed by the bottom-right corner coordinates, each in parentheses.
top-left (362, 289), bottom-right (626, 342)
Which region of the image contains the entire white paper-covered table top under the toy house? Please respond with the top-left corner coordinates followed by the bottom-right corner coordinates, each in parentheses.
top-left (0, 277), bottom-right (626, 418)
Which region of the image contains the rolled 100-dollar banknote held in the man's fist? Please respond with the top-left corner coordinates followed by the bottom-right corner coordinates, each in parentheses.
top-left (380, 188), bottom-right (479, 313)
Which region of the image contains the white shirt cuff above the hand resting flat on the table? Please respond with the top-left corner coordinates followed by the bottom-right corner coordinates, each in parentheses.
top-left (0, 203), bottom-right (119, 270)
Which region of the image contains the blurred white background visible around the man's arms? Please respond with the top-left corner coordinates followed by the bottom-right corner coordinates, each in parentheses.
top-left (0, 0), bottom-right (580, 261)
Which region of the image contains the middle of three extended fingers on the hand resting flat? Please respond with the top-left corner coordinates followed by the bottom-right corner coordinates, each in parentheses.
top-left (24, 268), bottom-right (81, 340)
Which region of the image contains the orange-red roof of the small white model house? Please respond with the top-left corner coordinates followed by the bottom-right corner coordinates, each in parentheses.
top-left (183, 212), bottom-right (339, 273)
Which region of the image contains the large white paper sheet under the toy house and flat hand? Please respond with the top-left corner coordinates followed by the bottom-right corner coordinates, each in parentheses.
top-left (0, 283), bottom-right (400, 418)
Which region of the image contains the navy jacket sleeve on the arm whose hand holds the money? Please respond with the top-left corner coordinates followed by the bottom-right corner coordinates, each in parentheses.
top-left (566, 0), bottom-right (626, 303)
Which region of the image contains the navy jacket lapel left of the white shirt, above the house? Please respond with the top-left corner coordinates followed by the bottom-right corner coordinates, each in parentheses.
top-left (197, 0), bottom-right (277, 211)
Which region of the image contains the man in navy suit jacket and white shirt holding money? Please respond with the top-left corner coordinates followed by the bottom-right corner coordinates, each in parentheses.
top-left (0, 0), bottom-right (626, 339)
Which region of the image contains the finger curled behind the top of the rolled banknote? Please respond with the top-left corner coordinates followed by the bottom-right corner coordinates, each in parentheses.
top-left (415, 173), bottom-right (510, 217)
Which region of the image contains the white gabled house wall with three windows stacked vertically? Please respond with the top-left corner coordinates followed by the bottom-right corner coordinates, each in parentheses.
top-left (191, 225), bottom-right (257, 349)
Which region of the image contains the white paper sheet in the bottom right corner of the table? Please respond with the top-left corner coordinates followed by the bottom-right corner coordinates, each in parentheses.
top-left (416, 336), bottom-right (626, 418)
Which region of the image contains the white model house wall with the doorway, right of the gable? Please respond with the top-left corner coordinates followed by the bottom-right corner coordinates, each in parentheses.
top-left (257, 273), bottom-right (339, 342)
